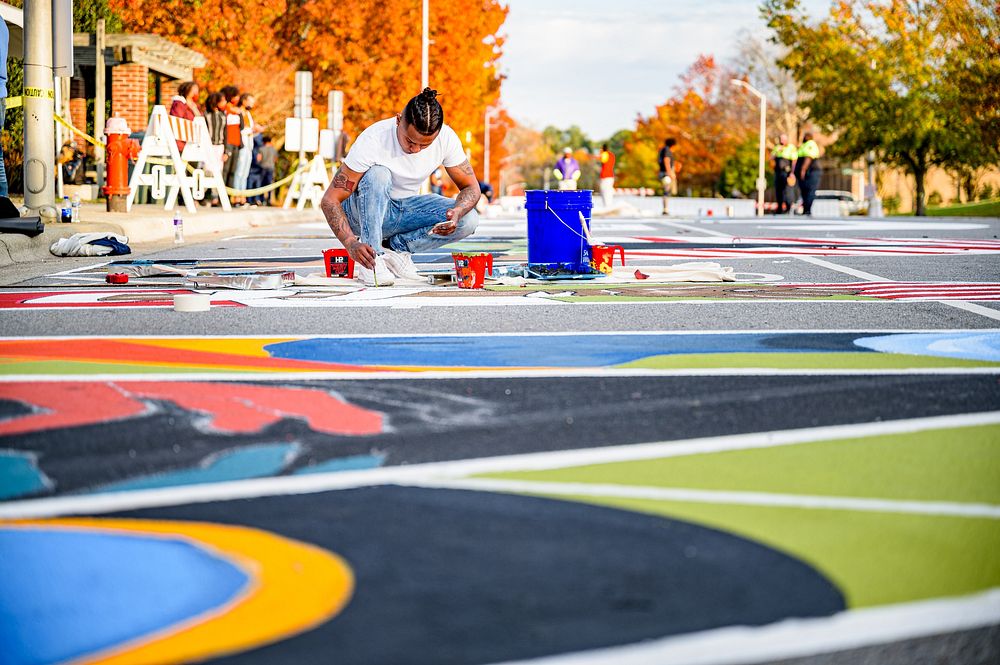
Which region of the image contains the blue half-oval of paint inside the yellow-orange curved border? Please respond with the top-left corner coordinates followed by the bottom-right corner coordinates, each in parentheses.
top-left (0, 527), bottom-right (250, 665)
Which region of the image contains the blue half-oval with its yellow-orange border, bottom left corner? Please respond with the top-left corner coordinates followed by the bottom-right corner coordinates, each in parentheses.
top-left (0, 518), bottom-right (354, 665)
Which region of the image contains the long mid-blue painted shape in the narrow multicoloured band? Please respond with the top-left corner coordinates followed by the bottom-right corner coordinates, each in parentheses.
top-left (264, 333), bottom-right (872, 367)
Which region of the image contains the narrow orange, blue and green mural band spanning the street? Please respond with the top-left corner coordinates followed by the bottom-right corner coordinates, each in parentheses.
top-left (0, 331), bottom-right (1000, 376)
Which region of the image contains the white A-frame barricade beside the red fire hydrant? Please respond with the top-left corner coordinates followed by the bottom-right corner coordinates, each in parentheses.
top-left (125, 106), bottom-right (231, 212)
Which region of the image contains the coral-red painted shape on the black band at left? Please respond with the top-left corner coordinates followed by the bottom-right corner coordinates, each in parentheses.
top-left (0, 381), bottom-right (383, 436)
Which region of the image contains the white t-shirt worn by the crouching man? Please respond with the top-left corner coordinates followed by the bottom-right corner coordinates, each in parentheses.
top-left (344, 118), bottom-right (465, 199)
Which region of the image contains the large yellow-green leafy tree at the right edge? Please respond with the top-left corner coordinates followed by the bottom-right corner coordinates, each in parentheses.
top-left (761, 0), bottom-right (1000, 215)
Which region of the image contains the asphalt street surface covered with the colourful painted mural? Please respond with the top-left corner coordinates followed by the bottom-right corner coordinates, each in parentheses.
top-left (0, 213), bottom-right (1000, 665)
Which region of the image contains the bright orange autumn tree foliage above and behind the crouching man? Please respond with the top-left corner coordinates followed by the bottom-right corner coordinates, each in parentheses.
top-left (109, 0), bottom-right (511, 175)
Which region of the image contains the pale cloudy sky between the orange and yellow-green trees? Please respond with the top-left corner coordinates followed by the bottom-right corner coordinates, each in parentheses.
top-left (500, 0), bottom-right (830, 141)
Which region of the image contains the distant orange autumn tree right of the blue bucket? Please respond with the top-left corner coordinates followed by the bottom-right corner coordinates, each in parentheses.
top-left (618, 56), bottom-right (757, 195)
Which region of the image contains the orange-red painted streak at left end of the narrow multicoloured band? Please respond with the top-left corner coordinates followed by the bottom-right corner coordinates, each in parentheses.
top-left (0, 339), bottom-right (377, 372)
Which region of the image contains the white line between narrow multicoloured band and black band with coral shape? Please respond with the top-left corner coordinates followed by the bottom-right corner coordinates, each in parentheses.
top-left (0, 365), bottom-right (1000, 385)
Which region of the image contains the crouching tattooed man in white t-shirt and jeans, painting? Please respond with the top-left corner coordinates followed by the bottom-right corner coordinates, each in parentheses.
top-left (320, 88), bottom-right (480, 286)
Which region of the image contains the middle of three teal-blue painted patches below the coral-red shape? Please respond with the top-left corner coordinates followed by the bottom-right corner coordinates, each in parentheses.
top-left (94, 443), bottom-right (300, 493)
